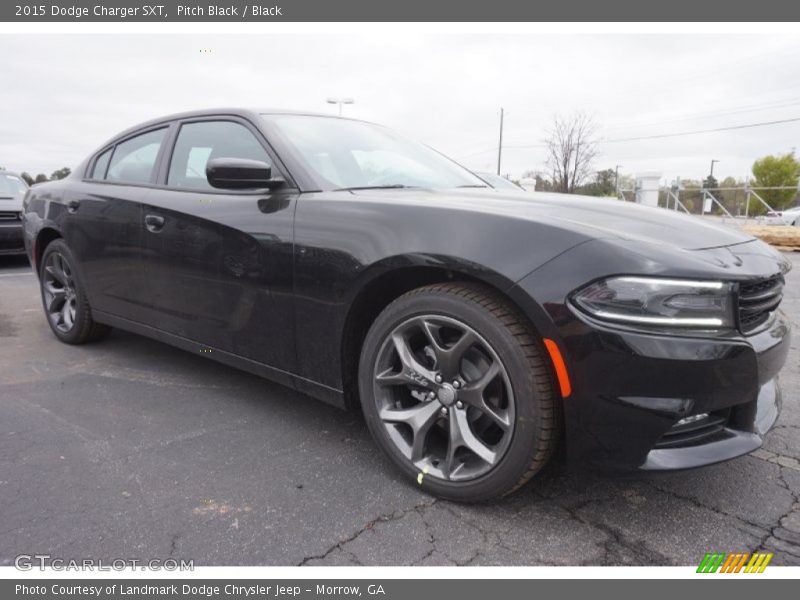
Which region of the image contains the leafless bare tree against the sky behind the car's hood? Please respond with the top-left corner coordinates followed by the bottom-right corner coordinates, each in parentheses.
top-left (544, 112), bottom-right (597, 194)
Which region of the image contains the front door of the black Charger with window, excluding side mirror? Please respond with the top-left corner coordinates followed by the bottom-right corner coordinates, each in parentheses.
top-left (142, 117), bottom-right (297, 369)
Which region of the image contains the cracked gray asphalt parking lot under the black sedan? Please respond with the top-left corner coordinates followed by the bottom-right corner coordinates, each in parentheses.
top-left (0, 253), bottom-right (800, 565)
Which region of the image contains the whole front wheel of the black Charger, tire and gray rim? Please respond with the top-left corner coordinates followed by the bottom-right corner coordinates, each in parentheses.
top-left (359, 283), bottom-right (560, 502)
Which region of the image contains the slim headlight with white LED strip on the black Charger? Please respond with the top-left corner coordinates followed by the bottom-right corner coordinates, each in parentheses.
top-left (572, 277), bottom-right (735, 329)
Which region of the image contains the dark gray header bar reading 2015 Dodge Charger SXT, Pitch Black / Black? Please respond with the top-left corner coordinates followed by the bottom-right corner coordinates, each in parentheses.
top-left (0, 0), bottom-right (800, 23)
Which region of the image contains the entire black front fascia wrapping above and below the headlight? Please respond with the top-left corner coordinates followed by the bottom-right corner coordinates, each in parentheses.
top-left (509, 241), bottom-right (791, 471)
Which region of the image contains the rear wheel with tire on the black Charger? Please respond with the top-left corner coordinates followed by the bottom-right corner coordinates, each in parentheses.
top-left (39, 239), bottom-right (111, 344)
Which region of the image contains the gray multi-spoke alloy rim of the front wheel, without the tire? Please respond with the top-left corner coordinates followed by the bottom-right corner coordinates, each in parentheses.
top-left (374, 314), bottom-right (515, 481)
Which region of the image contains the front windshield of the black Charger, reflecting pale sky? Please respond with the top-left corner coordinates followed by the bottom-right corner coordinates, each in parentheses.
top-left (269, 115), bottom-right (486, 190)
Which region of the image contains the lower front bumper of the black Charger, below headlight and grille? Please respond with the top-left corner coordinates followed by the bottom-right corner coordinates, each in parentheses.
top-left (564, 312), bottom-right (790, 470)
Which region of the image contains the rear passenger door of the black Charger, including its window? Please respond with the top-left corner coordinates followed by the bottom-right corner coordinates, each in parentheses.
top-left (62, 125), bottom-right (169, 321)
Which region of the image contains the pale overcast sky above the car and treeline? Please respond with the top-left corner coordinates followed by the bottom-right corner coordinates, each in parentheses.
top-left (0, 33), bottom-right (800, 179)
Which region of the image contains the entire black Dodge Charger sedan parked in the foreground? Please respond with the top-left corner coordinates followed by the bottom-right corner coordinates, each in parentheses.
top-left (24, 109), bottom-right (789, 501)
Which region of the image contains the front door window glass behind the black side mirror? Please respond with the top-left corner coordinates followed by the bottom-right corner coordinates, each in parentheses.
top-left (167, 121), bottom-right (272, 190)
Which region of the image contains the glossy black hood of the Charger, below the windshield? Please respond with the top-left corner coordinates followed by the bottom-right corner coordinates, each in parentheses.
top-left (356, 189), bottom-right (754, 250)
